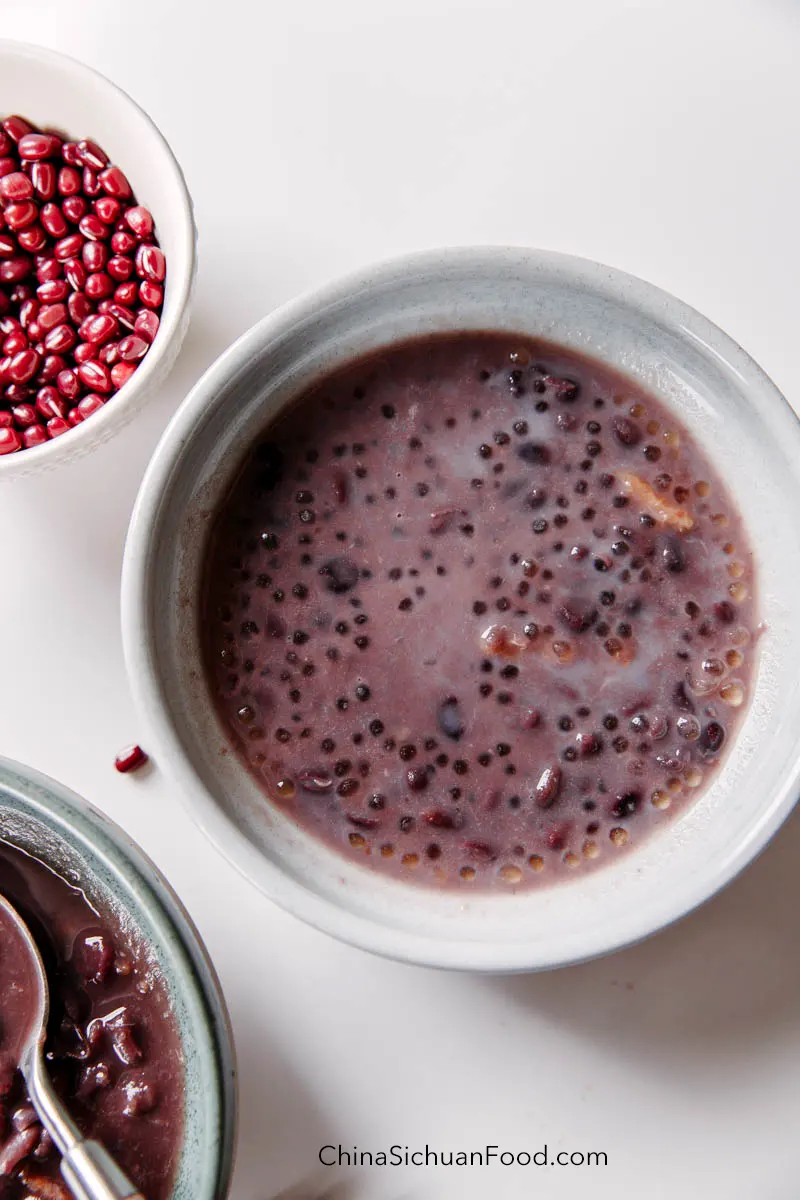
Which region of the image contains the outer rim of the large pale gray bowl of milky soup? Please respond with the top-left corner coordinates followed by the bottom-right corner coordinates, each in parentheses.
top-left (121, 245), bottom-right (800, 972)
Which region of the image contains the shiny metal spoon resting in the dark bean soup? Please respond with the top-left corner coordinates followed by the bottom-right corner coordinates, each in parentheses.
top-left (0, 895), bottom-right (144, 1200)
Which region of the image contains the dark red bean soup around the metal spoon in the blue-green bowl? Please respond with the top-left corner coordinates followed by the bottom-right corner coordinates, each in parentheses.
top-left (0, 841), bottom-right (184, 1200)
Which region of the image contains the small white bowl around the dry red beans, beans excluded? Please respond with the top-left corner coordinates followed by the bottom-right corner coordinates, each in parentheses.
top-left (0, 40), bottom-right (197, 481)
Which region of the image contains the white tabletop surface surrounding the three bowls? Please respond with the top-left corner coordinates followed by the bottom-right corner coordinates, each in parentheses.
top-left (0, 0), bottom-right (800, 1200)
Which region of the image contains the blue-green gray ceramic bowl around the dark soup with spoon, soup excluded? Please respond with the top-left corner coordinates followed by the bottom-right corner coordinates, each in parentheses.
top-left (0, 758), bottom-right (236, 1200)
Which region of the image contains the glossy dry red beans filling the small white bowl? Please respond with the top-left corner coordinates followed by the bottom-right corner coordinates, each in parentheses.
top-left (0, 115), bottom-right (167, 456)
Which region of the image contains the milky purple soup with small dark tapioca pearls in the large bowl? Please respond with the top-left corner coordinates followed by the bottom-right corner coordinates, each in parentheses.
top-left (203, 332), bottom-right (757, 888)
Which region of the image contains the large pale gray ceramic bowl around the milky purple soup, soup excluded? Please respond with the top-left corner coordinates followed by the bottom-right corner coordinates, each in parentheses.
top-left (122, 248), bottom-right (800, 970)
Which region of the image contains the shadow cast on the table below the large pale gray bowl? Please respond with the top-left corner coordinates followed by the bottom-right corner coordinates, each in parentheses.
top-left (485, 811), bottom-right (800, 1085)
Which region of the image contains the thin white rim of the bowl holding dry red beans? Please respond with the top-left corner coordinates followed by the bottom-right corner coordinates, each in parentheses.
top-left (0, 37), bottom-right (197, 482)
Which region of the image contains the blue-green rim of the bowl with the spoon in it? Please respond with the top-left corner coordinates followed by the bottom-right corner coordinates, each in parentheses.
top-left (0, 756), bottom-right (239, 1200)
